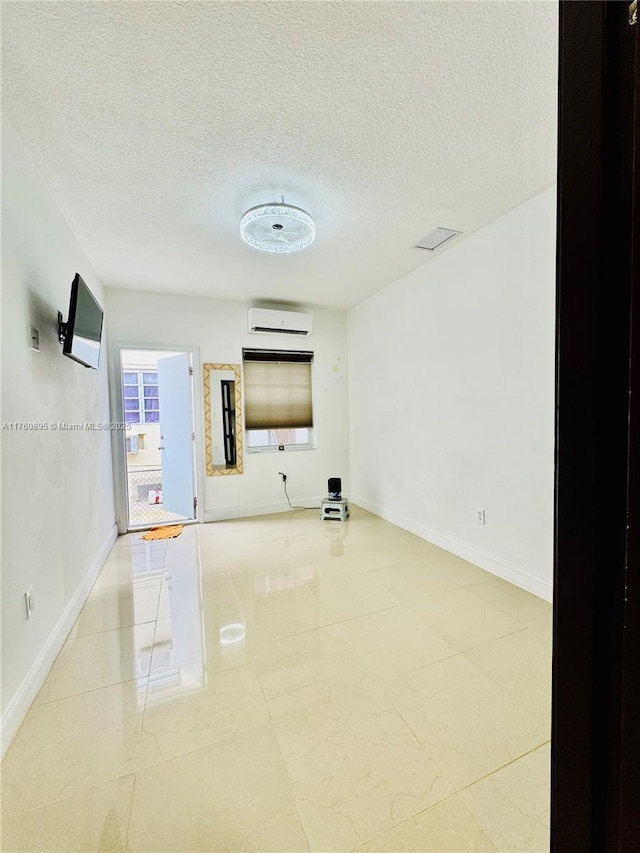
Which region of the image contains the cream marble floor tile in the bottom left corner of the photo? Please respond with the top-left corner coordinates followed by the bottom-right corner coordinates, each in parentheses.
top-left (2, 775), bottom-right (134, 853)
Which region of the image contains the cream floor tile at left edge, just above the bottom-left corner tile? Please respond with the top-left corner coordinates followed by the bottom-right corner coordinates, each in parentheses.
top-left (2, 682), bottom-right (146, 818)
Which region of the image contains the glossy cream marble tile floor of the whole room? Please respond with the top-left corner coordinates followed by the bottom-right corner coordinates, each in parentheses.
top-left (2, 507), bottom-right (551, 853)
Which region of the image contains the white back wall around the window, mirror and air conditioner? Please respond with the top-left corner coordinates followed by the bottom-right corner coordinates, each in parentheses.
top-left (106, 290), bottom-right (349, 521)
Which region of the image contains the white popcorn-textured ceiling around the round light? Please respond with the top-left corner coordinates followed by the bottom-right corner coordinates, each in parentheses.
top-left (2, 0), bottom-right (557, 307)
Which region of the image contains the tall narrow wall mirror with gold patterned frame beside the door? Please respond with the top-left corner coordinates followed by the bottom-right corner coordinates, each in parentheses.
top-left (202, 364), bottom-right (242, 477)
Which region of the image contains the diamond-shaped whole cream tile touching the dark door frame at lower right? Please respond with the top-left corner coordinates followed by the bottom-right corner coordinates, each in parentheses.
top-left (385, 655), bottom-right (548, 790)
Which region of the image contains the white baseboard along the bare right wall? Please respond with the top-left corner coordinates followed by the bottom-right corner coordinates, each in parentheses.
top-left (351, 495), bottom-right (553, 602)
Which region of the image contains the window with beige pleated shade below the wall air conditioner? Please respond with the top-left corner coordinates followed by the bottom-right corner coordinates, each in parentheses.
top-left (242, 349), bottom-right (313, 450)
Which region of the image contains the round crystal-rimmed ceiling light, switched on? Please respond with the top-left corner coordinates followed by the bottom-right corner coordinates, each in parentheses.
top-left (240, 197), bottom-right (316, 255)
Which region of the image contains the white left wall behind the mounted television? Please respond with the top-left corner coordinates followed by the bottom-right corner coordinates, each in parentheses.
top-left (2, 118), bottom-right (116, 747)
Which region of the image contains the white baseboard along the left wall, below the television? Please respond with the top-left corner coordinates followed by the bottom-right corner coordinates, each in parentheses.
top-left (0, 524), bottom-right (118, 755)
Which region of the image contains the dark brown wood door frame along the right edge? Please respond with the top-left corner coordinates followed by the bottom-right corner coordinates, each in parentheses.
top-left (551, 0), bottom-right (640, 853)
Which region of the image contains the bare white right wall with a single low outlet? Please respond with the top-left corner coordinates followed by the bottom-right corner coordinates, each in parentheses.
top-left (348, 188), bottom-right (555, 600)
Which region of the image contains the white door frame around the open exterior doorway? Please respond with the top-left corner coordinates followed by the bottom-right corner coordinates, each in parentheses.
top-left (109, 341), bottom-right (204, 535)
